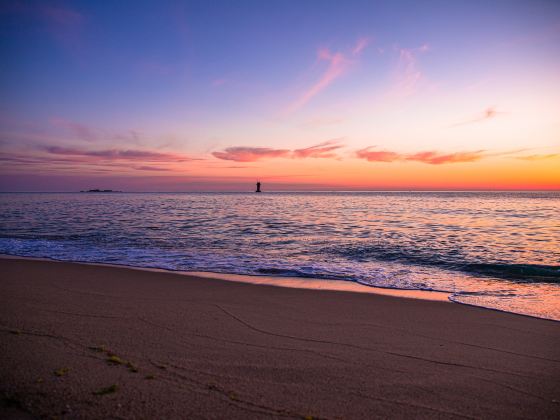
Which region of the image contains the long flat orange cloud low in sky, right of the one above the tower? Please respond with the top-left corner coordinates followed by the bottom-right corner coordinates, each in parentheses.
top-left (356, 147), bottom-right (486, 165)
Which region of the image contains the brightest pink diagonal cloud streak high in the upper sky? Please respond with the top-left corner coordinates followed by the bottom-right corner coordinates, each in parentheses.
top-left (288, 38), bottom-right (369, 113)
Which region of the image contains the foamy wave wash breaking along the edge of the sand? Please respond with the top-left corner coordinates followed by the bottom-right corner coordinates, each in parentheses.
top-left (0, 237), bottom-right (560, 320)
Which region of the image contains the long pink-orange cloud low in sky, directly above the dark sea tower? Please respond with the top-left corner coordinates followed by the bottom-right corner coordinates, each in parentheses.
top-left (212, 139), bottom-right (344, 162)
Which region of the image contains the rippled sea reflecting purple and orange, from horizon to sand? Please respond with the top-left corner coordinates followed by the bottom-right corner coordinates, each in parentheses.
top-left (0, 192), bottom-right (560, 320)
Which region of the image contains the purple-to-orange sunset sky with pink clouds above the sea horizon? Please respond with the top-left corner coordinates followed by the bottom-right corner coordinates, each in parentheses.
top-left (0, 0), bottom-right (560, 191)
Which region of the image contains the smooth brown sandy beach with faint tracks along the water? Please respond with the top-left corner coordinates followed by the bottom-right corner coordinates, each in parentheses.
top-left (0, 259), bottom-right (560, 419)
